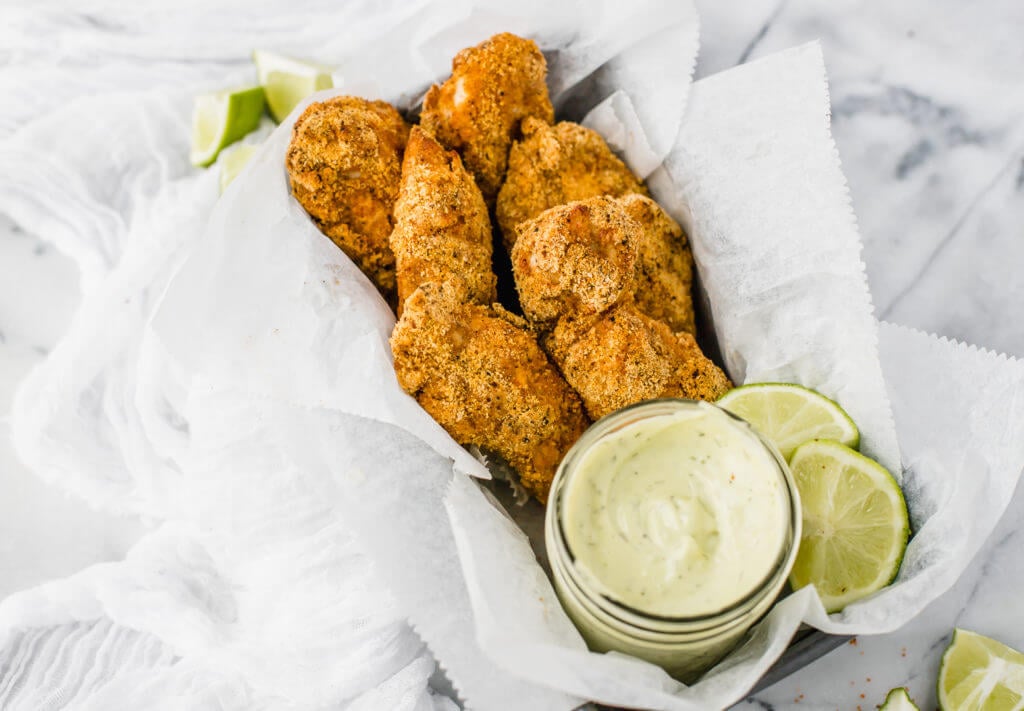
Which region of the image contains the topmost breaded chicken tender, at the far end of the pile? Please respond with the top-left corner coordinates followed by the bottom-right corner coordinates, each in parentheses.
top-left (420, 33), bottom-right (555, 205)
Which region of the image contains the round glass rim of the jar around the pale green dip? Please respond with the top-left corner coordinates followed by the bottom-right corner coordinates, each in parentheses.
top-left (547, 398), bottom-right (802, 631)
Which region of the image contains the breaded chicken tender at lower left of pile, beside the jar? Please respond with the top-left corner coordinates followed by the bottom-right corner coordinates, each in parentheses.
top-left (391, 281), bottom-right (589, 502)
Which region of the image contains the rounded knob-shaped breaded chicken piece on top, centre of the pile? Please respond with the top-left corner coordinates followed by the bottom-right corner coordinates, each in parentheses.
top-left (512, 197), bottom-right (641, 325)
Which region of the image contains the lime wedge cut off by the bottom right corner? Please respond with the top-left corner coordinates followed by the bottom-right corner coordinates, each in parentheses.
top-left (938, 629), bottom-right (1024, 711)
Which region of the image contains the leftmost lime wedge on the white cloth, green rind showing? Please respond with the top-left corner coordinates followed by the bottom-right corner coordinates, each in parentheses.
top-left (188, 86), bottom-right (264, 166)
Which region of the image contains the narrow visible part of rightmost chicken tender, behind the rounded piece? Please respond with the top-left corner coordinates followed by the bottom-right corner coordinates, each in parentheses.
top-left (618, 195), bottom-right (696, 333)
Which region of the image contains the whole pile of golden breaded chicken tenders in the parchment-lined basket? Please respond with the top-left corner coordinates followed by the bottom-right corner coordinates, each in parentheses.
top-left (286, 34), bottom-right (731, 502)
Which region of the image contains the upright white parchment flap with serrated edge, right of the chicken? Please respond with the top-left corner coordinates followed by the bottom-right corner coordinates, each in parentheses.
top-left (651, 44), bottom-right (900, 476)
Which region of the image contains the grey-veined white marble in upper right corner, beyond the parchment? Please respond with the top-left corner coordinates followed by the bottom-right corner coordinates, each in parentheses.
top-left (697, 0), bottom-right (1024, 354)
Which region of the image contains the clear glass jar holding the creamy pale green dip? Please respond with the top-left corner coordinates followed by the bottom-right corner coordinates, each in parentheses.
top-left (545, 400), bottom-right (801, 682)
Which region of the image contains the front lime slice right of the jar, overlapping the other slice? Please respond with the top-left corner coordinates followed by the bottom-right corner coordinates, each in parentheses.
top-left (790, 440), bottom-right (910, 613)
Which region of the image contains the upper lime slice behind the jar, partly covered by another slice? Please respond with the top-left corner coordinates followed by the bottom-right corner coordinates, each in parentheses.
top-left (718, 383), bottom-right (860, 461)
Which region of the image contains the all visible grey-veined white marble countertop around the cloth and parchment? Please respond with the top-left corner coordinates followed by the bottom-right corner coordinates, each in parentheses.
top-left (0, 0), bottom-right (1024, 710)
